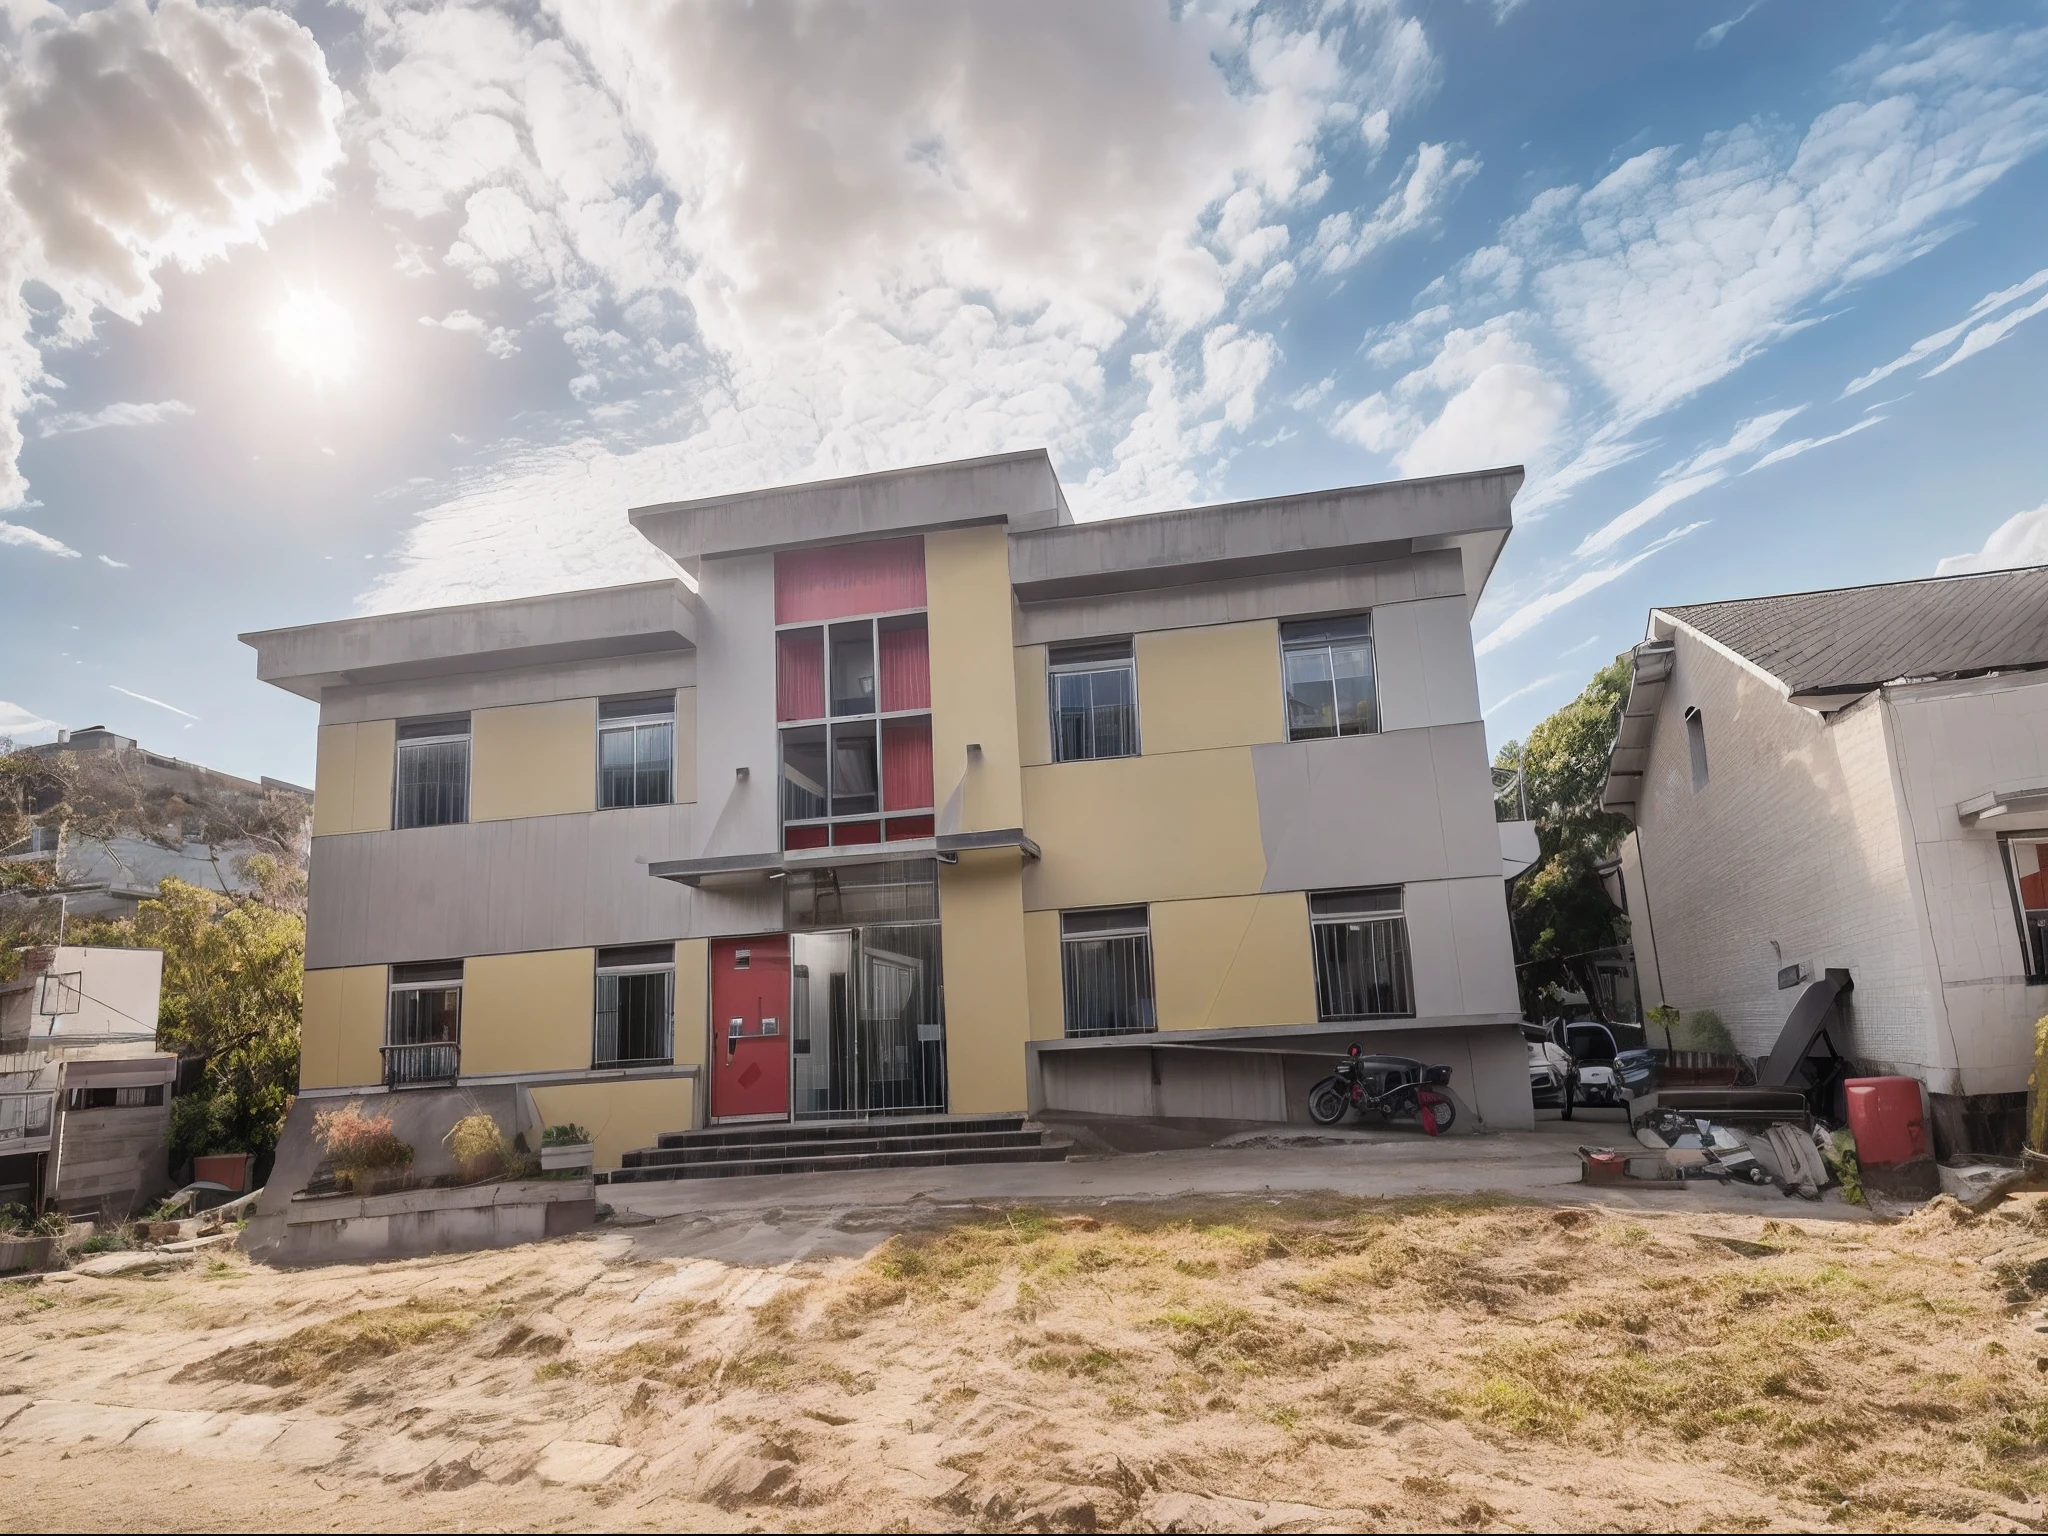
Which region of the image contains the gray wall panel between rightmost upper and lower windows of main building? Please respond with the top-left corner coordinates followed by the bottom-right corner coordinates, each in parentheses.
top-left (1251, 721), bottom-right (1501, 891)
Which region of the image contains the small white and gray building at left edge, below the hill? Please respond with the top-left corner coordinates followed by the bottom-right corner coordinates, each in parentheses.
top-left (0, 946), bottom-right (178, 1221)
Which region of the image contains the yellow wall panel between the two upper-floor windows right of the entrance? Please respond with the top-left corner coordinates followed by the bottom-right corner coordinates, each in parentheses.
top-left (1137, 618), bottom-right (1286, 754)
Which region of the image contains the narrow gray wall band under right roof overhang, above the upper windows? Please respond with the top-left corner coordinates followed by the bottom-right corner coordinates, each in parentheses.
top-left (1018, 551), bottom-right (1470, 655)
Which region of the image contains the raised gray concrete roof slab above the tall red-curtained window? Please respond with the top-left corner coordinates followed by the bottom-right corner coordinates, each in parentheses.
top-left (629, 449), bottom-right (1071, 571)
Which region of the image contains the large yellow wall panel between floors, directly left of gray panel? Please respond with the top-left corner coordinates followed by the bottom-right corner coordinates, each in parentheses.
top-left (1024, 748), bottom-right (1266, 911)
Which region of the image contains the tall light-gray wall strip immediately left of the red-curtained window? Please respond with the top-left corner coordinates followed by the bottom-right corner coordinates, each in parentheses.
top-left (692, 555), bottom-right (780, 858)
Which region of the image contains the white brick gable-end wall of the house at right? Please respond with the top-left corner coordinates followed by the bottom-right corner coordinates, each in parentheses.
top-left (1628, 629), bottom-right (1950, 1087)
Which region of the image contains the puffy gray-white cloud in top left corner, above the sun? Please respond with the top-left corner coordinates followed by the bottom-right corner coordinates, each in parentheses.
top-left (0, 0), bottom-right (342, 508)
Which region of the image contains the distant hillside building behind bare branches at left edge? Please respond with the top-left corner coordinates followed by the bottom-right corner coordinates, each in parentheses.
top-left (0, 725), bottom-right (313, 918)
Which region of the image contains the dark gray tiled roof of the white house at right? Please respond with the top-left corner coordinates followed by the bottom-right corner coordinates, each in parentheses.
top-left (1661, 565), bottom-right (2048, 694)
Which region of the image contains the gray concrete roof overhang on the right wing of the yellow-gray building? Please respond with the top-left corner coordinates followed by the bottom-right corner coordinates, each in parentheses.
top-left (1010, 465), bottom-right (1522, 618)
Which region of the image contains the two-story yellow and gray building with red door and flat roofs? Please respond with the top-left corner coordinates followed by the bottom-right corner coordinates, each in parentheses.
top-left (246, 453), bottom-right (1532, 1167)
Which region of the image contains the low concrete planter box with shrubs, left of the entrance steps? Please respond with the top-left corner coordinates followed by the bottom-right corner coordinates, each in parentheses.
top-left (272, 1178), bottom-right (598, 1264)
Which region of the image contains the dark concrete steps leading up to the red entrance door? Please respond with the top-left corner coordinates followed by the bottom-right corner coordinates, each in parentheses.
top-left (598, 1114), bottom-right (1067, 1184)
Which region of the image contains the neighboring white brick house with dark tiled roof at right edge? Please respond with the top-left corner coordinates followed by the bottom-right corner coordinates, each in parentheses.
top-left (1604, 567), bottom-right (2048, 1151)
